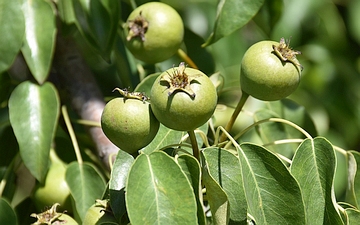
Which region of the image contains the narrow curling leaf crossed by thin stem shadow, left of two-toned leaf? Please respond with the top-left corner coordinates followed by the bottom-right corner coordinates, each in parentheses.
top-left (203, 148), bottom-right (247, 224)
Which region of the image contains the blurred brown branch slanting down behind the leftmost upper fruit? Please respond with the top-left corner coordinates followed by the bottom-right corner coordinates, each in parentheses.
top-left (53, 35), bottom-right (118, 169)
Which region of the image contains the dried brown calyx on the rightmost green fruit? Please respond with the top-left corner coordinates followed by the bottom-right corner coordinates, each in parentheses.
top-left (272, 38), bottom-right (303, 71)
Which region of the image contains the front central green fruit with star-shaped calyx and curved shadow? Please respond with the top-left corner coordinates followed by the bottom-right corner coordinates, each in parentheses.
top-left (150, 63), bottom-right (217, 131)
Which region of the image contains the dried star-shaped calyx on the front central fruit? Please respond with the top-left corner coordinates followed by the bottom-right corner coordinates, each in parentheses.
top-left (160, 62), bottom-right (200, 98)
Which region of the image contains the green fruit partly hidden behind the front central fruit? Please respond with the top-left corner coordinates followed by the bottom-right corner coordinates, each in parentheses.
top-left (101, 98), bottom-right (160, 154)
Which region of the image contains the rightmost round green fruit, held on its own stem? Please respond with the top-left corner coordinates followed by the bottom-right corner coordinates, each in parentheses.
top-left (240, 39), bottom-right (302, 101)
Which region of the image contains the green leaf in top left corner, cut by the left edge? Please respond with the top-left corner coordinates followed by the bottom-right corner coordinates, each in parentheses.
top-left (0, 0), bottom-right (25, 74)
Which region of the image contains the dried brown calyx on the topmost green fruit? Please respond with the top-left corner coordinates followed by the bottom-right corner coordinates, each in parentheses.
top-left (126, 11), bottom-right (149, 42)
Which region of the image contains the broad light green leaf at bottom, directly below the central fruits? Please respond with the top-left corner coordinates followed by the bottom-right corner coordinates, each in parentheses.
top-left (125, 151), bottom-right (197, 225)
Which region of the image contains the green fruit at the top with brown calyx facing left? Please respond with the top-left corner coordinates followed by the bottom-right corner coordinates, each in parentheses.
top-left (124, 2), bottom-right (184, 64)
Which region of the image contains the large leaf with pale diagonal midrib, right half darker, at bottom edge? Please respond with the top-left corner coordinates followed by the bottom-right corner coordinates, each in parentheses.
top-left (237, 143), bottom-right (305, 225)
